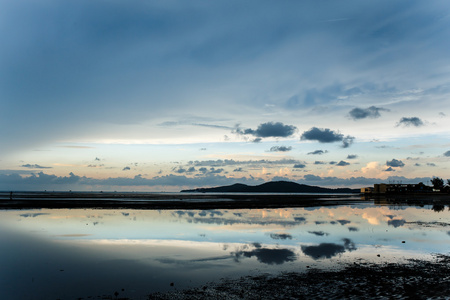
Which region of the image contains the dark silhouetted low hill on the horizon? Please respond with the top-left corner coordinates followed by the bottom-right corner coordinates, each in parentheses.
top-left (181, 181), bottom-right (360, 193)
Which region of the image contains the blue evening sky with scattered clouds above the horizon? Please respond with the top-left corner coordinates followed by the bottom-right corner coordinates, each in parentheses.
top-left (0, 0), bottom-right (450, 192)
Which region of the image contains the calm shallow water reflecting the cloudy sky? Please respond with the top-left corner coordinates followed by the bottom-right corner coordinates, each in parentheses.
top-left (0, 203), bottom-right (450, 299)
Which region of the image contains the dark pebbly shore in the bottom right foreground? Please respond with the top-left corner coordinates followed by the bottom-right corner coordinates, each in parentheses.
top-left (149, 255), bottom-right (450, 299)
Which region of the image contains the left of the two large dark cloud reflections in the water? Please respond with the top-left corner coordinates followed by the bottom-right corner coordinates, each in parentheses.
top-left (231, 248), bottom-right (297, 265)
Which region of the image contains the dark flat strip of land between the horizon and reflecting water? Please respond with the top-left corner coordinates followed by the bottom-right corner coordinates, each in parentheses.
top-left (0, 192), bottom-right (450, 209)
